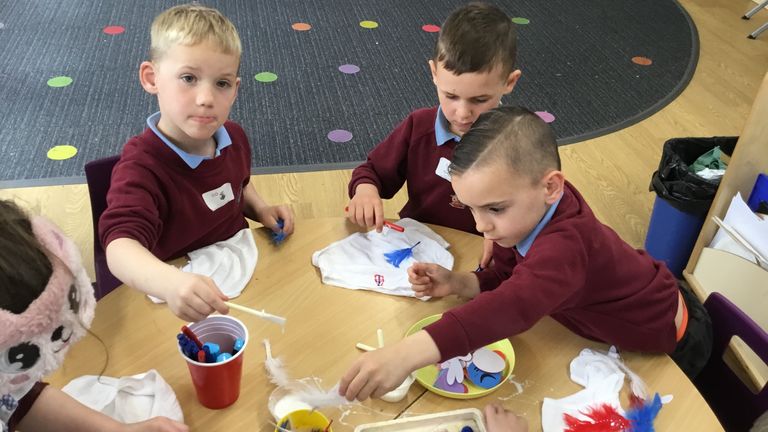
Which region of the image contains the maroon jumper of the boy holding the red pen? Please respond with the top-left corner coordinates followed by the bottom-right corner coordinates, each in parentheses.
top-left (349, 107), bottom-right (478, 234)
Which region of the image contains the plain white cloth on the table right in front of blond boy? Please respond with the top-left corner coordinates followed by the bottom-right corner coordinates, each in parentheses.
top-left (149, 228), bottom-right (259, 303)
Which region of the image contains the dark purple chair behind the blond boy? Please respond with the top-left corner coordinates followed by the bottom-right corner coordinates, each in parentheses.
top-left (85, 156), bottom-right (122, 300)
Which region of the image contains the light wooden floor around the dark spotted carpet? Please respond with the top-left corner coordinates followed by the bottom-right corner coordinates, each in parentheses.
top-left (0, 0), bottom-right (768, 275)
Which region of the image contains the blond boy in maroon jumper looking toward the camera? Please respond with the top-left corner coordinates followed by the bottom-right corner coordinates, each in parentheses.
top-left (99, 4), bottom-right (293, 321)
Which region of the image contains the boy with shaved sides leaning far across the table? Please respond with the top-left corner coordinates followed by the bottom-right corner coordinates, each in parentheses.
top-left (340, 107), bottom-right (712, 400)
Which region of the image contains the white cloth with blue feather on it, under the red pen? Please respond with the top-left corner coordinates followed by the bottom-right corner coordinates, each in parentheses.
top-left (312, 218), bottom-right (453, 300)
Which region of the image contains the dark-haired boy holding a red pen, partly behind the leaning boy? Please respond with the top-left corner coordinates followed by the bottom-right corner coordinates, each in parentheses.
top-left (348, 3), bottom-right (521, 248)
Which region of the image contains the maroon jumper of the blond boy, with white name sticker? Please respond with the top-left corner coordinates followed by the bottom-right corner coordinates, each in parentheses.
top-left (99, 121), bottom-right (251, 261)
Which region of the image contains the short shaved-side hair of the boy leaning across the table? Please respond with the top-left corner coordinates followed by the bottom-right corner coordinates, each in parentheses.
top-left (449, 106), bottom-right (560, 183)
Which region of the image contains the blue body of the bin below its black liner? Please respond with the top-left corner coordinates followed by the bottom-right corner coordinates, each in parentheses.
top-left (645, 196), bottom-right (704, 278)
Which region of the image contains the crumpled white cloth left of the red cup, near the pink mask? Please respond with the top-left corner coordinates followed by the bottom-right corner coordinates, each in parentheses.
top-left (62, 369), bottom-right (184, 423)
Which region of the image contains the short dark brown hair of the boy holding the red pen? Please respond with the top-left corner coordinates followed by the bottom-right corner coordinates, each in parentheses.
top-left (433, 3), bottom-right (517, 79)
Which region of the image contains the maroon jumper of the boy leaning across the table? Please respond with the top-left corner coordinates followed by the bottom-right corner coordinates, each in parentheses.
top-left (426, 182), bottom-right (679, 360)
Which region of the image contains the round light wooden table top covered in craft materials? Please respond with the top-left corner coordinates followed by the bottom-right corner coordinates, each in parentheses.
top-left (48, 217), bottom-right (722, 431)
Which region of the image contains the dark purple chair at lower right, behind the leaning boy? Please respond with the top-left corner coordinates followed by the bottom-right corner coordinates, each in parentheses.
top-left (693, 292), bottom-right (768, 432)
